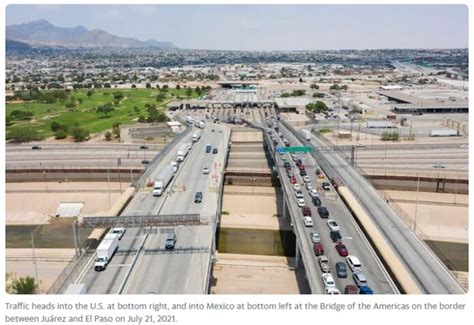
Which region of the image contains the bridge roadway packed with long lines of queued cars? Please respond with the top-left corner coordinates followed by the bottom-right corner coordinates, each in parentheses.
top-left (256, 114), bottom-right (397, 294)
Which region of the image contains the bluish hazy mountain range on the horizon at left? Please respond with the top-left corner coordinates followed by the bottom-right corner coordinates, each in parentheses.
top-left (6, 20), bottom-right (175, 48)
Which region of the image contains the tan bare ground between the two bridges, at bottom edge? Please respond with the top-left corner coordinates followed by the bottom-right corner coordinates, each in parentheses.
top-left (211, 254), bottom-right (310, 294)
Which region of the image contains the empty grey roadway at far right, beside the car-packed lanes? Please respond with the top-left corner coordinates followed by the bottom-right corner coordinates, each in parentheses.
top-left (284, 120), bottom-right (464, 294)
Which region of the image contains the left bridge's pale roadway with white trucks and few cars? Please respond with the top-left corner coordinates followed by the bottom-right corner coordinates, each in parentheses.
top-left (75, 124), bottom-right (229, 294)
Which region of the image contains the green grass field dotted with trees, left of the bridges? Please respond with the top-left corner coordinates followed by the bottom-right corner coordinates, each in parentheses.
top-left (6, 89), bottom-right (198, 138)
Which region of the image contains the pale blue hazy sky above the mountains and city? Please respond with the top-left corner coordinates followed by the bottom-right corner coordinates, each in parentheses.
top-left (6, 5), bottom-right (468, 50)
